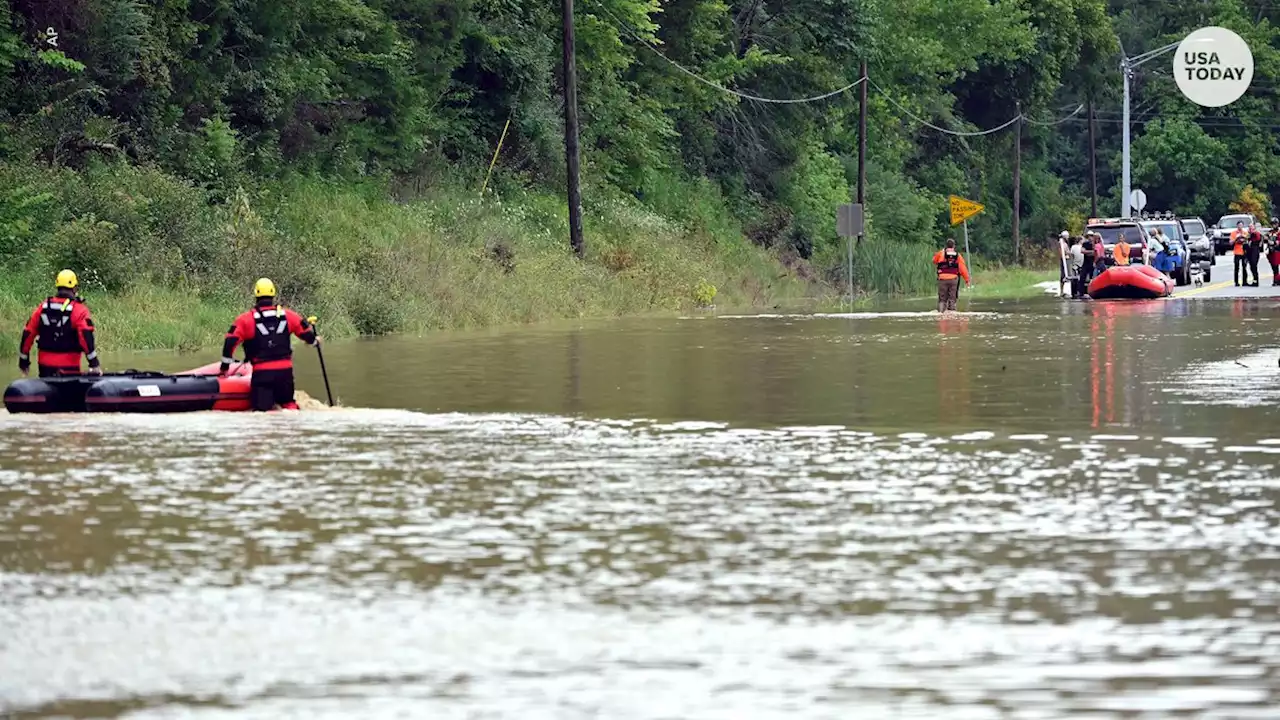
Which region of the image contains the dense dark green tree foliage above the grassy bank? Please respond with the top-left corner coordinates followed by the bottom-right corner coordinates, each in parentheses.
top-left (0, 0), bottom-right (1280, 280)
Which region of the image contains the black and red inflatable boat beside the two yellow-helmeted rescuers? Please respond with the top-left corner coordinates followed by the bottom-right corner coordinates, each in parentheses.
top-left (4, 363), bottom-right (253, 413)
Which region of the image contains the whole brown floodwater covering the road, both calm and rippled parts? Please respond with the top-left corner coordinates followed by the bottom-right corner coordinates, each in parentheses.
top-left (0, 294), bottom-right (1280, 719)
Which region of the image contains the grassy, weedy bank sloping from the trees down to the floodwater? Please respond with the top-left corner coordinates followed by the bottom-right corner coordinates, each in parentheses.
top-left (0, 164), bottom-right (814, 356)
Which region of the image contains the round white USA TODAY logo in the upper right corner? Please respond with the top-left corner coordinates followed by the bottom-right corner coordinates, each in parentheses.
top-left (1174, 27), bottom-right (1253, 108)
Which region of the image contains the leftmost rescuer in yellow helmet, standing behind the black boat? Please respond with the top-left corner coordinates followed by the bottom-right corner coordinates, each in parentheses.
top-left (18, 270), bottom-right (102, 378)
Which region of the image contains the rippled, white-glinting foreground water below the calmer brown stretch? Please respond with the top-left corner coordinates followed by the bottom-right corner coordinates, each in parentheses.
top-left (0, 411), bottom-right (1280, 717)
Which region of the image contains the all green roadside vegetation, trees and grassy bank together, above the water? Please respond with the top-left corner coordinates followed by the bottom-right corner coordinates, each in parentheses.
top-left (0, 0), bottom-right (1280, 354)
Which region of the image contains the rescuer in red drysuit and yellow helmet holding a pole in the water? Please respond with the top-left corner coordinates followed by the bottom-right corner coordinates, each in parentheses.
top-left (219, 278), bottom-right (320, 411)
